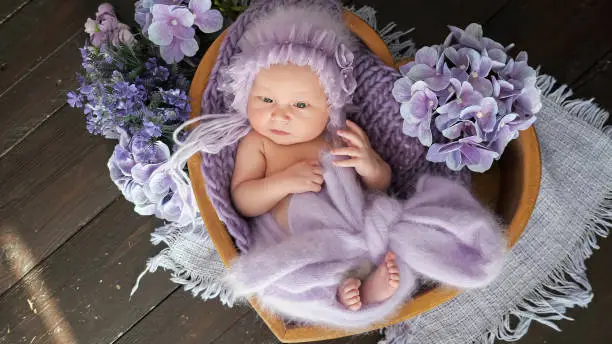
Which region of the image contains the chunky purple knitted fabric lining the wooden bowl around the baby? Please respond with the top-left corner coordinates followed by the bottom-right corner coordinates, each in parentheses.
top-left (201, 0), bottom-right (469, 251)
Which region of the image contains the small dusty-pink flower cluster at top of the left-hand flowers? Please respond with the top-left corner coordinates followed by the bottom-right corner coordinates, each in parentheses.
top-left (85, 3), bottom-right (136, 48)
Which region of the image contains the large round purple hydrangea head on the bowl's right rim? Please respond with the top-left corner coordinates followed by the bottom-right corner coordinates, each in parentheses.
top-left (393, 24), bottom-right (542, 172)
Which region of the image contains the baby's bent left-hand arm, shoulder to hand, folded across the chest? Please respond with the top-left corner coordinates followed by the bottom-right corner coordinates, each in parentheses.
top-left (231, 131), bottom-right (323, 217)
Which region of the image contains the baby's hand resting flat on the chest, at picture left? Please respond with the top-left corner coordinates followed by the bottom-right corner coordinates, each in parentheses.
top-left (278, 160), bottom-right (323, 194)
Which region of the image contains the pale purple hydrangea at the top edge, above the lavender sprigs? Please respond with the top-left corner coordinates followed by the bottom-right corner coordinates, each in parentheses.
top-left (135, 0), bottom-right (223, 63)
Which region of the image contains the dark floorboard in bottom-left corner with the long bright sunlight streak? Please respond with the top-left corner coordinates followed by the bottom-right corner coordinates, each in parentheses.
top-left (0, 199), bottom-right (177, 344)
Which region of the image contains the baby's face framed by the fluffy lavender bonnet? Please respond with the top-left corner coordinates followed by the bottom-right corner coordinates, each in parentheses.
top-left (247, 64), bottom-right (329, 145)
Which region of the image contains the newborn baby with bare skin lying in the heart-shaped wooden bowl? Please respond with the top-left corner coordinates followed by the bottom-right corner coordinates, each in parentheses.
top-left (231, 64), bottom-right (400, 311)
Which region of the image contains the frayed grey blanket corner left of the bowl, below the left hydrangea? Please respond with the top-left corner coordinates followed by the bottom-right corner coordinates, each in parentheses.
top-left (130, 222), bottom-right (236, 307)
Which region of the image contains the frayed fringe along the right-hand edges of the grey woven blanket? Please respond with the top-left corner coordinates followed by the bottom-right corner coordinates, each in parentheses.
top-left (475, 75), bottom-right (612, 344)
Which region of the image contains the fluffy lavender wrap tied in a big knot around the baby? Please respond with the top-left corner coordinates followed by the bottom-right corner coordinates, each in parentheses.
top-left (227, 154), bottom-right (505, 329)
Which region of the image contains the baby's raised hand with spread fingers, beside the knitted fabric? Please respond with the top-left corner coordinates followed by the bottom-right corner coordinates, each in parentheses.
top-left (332, 120), bottom-right (386, 179)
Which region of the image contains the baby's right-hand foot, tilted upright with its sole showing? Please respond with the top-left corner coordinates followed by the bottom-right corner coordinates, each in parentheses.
top-left (361, 252), bottom-right (399, 305)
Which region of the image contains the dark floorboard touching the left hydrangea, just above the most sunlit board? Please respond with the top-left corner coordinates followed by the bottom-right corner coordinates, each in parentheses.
top-left (0, 107), bottom-right (119, 294)
